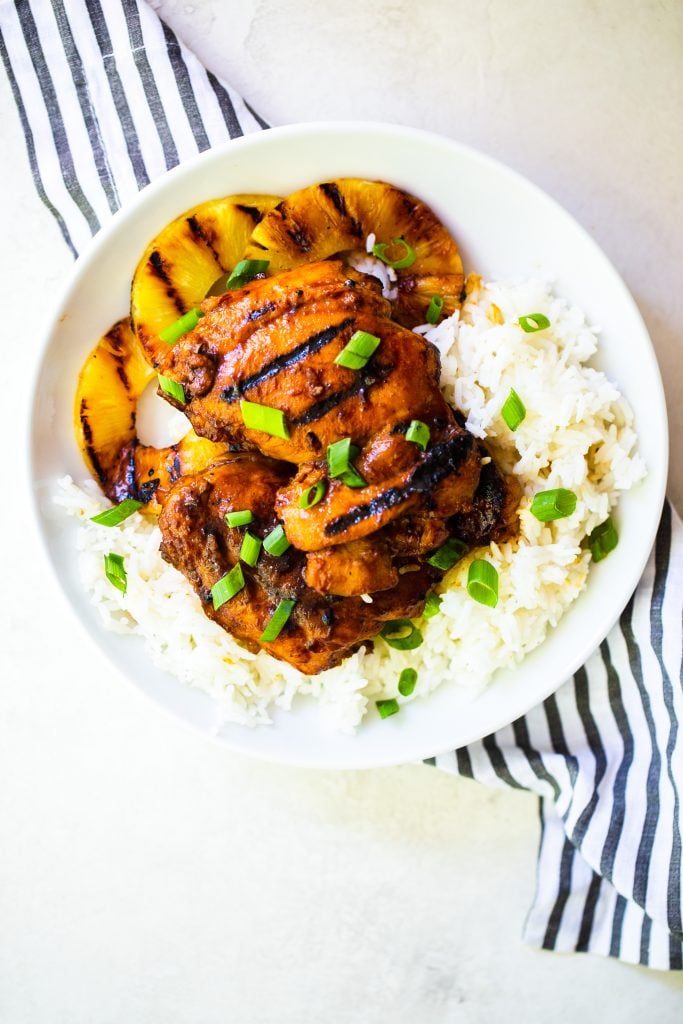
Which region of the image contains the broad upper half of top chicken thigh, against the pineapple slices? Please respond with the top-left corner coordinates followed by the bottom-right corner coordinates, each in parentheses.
top-left (157, 262), bottom-right (401, 463)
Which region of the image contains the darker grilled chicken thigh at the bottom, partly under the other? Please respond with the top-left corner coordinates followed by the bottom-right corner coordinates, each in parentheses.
top-left (159, 455), bottom-right (440, 675)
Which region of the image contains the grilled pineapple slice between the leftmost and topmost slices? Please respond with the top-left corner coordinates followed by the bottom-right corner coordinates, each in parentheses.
top-left (130, 196), bottom-right (280, 367)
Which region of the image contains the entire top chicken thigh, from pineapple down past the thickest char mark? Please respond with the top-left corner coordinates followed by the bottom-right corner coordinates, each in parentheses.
top-left (162, 256), bottom-right (480, 551)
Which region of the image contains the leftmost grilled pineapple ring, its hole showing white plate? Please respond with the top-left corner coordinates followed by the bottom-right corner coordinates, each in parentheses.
top-left (75, 319), bottom-right (227, 514)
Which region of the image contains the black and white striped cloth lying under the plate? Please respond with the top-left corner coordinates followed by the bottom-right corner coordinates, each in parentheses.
top-left (0, 0), bottom-right (683, 969)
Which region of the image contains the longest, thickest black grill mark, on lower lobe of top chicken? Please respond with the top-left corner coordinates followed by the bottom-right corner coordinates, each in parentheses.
top-left (325, 434), bottom-right (474, 537)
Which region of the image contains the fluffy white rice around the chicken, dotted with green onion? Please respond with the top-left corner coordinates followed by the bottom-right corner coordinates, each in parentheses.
top-left (57, 280), bottom-right (645, 730)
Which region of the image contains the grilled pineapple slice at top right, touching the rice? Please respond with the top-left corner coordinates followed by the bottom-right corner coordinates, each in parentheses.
top-left (245, 178), bottom-right (464, 327)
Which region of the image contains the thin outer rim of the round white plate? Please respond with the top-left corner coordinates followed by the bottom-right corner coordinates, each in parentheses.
top-left (23, 120), bottom-right (670, 770)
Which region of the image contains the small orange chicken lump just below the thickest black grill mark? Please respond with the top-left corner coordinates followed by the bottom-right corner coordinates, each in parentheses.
top-left (303, 538), bottom-right (400, 597)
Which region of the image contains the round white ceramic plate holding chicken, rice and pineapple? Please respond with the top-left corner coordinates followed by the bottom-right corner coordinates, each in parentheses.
top-left (31, 124), bottom-right (668, 768)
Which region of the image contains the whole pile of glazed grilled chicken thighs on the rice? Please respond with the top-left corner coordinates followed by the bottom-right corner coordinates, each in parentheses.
top-left (154, 260), bottom-right (516, 674)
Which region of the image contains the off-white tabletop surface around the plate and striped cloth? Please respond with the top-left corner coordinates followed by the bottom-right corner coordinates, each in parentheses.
top-left (0, 0), bottom-right (683, 1024)
